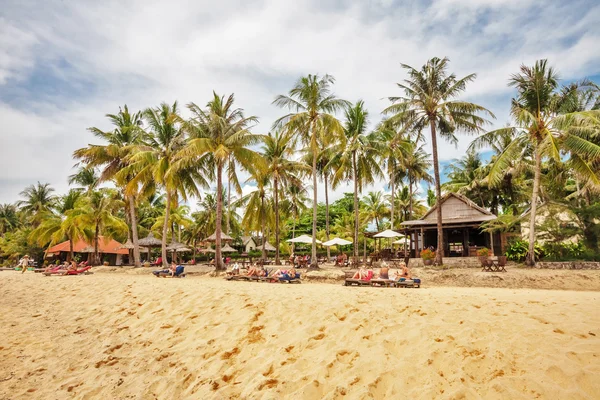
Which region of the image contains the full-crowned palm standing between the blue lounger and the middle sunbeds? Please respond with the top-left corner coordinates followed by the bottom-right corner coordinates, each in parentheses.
top-left (180, 92), bottom-right (261, 270)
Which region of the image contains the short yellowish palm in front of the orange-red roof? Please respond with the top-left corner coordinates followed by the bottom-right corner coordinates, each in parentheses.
top-left (71, 189), bottom-right (128, 265)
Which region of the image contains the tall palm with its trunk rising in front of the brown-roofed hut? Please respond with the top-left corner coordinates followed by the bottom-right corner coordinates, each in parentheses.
top-left (384, 57), bottom-right (494, 265)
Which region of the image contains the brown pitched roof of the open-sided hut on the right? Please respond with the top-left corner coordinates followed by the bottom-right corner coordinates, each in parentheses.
top-left (401, 193), bottom-right (498, 227)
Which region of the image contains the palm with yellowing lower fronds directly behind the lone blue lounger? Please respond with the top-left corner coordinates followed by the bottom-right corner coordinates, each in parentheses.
top-left (123, 102), bottom-right (207, 268)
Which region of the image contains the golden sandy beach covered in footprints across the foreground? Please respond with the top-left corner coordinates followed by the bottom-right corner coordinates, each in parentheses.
top-left (0, 271), bottom-right (600, 399)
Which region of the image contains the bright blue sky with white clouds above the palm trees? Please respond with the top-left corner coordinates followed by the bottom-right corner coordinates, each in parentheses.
top-left (0, 0), bottom-right (600, 203)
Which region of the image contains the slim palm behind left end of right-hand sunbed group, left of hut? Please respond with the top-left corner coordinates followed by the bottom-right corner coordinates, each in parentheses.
top-left (333, 100), bottom-right (382, 259)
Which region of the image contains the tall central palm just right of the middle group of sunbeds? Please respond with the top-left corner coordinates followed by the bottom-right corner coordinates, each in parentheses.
top-left (273, 75), bottom-right (348, 267)
